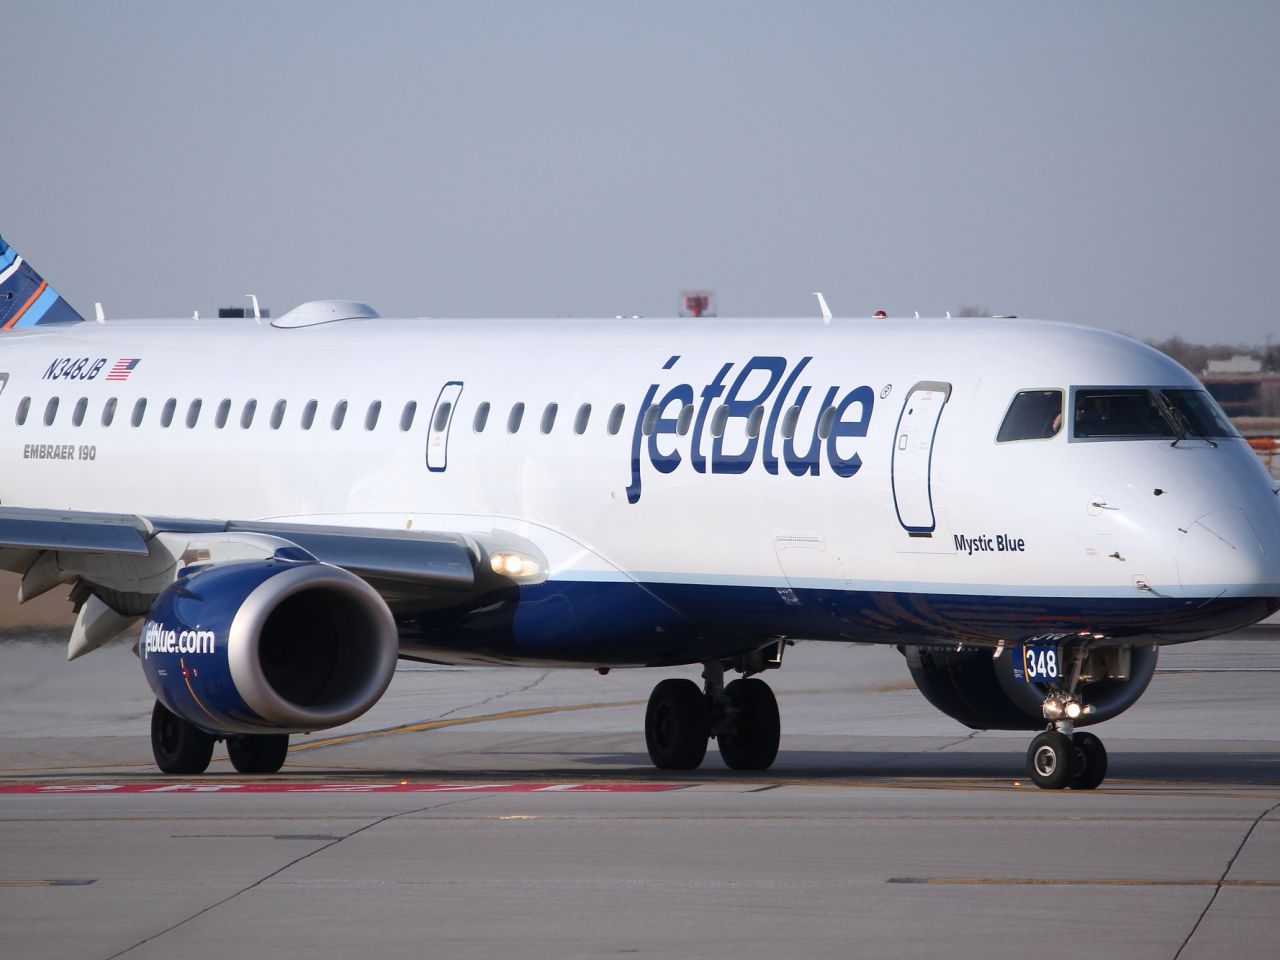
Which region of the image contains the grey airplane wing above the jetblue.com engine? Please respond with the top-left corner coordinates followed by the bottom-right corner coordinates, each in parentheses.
top-left (0, 507), bottom-right (547, 659)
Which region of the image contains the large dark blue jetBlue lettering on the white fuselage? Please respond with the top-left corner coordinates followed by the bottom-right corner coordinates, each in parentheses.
top-left (627, 356), bottom-right (876, 503)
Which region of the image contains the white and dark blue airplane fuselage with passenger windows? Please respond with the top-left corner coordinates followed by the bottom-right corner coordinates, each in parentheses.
top-left (0, 319), bottom-right (1280, 666)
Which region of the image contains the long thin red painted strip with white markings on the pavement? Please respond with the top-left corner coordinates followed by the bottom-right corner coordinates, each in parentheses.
top-left (0, 783), bottom-right (685, 794)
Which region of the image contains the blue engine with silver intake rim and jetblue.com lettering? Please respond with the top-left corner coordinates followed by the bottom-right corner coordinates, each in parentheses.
top-left (138, 557), bottom-right (398, 733)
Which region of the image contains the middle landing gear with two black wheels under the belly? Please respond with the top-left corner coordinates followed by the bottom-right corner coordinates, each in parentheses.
top-left (644, 648), bottom-right (782, 771)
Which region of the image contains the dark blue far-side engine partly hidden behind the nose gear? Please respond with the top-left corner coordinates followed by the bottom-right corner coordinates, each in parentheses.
top-left (901, 646), bottom-right (1157, 730)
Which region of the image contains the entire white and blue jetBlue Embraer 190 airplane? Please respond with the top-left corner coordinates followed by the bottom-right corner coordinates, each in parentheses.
top-left (0, 232), bottom-right (1280, 788)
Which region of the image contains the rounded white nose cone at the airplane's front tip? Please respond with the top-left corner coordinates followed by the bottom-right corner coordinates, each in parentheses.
top-left (1178, 509), bottom-right (1280, 596)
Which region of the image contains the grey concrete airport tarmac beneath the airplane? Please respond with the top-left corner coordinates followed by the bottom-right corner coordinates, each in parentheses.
top-left (0, 625), bottom-right (1280, 960)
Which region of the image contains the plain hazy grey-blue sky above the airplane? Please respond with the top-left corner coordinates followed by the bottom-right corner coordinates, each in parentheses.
top-left (0, 0), bottom-right (1280, 343)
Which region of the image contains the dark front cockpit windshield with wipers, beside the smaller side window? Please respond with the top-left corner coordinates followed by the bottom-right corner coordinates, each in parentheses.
top-left (1073, 387), bottom-right (1239, 440)
